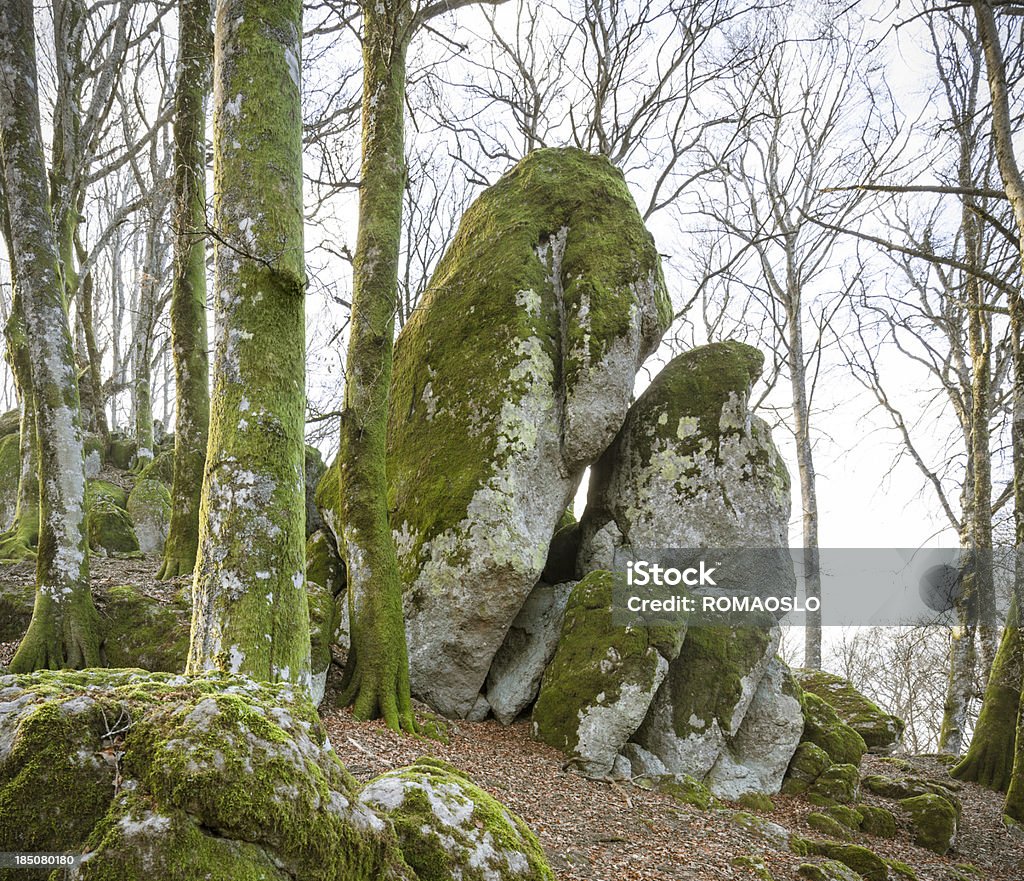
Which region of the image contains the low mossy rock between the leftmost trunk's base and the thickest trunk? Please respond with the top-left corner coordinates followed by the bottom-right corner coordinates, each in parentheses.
top-left (97, 585), bottom-right (191, 673)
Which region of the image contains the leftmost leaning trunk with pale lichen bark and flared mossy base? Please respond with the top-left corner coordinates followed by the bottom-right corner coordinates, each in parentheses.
top-left (0, 0), bottom-right (99, 672)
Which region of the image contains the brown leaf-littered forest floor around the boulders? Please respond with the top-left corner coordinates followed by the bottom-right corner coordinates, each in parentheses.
top-left (0, 556), bottom-right (1024, 881)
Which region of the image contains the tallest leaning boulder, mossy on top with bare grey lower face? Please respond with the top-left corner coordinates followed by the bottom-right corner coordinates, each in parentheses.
top-left (380, 149), bottom-right (672, 716)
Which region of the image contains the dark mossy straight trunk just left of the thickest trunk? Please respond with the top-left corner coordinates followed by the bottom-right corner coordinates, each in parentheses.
top-left (157, 0), bottom-right (213, 579)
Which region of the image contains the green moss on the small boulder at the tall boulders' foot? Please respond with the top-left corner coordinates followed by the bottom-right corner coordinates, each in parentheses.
top-left (532, 571), bottom-right (664, 755)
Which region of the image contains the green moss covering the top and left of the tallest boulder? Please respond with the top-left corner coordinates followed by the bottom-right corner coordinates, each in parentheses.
top-left (388, 149), bottom-right (672, 569)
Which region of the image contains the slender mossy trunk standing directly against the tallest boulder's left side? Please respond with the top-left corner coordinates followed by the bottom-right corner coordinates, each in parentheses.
top-left (338, 0), bottom-right (415, 731)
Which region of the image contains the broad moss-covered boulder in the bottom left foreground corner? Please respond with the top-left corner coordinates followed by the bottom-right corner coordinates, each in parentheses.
top-left (0, 670), bottom-right (414, 881)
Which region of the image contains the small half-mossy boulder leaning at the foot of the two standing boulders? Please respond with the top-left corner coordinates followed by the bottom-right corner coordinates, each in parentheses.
top-left (532, 572), bottom-right (682, 777)
